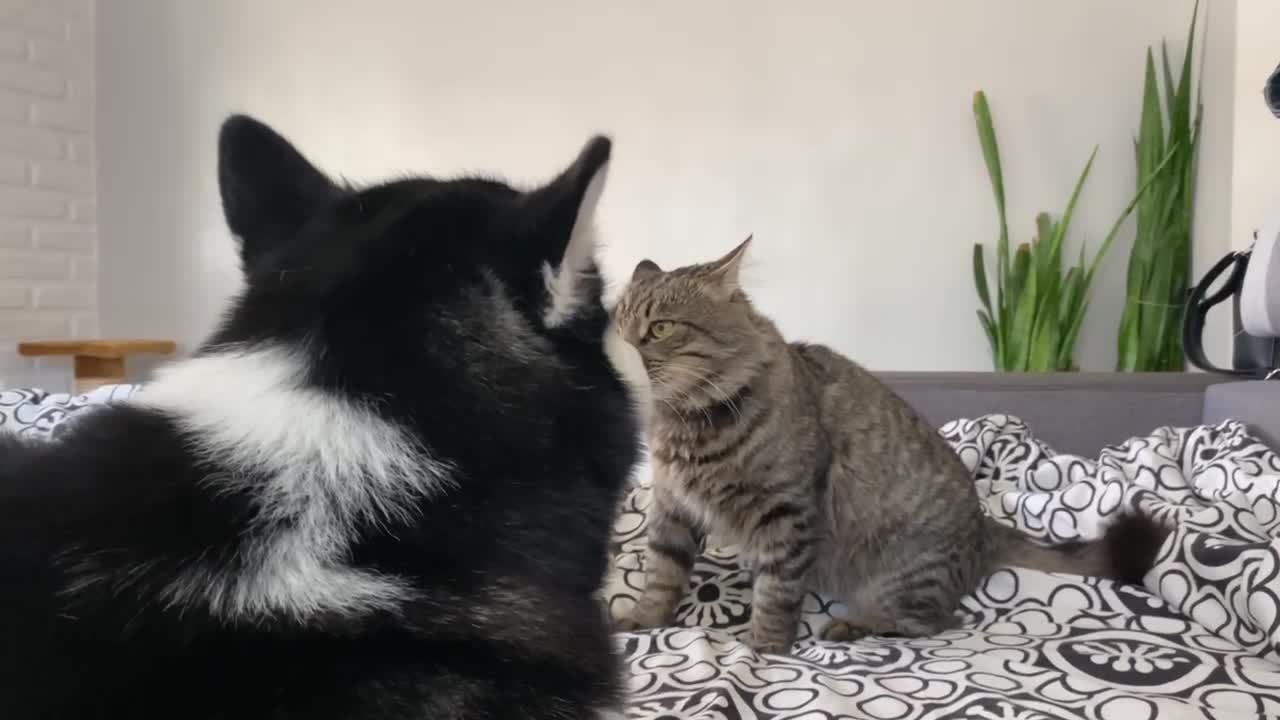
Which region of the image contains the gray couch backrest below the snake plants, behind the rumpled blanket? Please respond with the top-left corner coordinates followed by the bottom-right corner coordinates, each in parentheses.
top-left (878, 373), bottom-right (1280, 456)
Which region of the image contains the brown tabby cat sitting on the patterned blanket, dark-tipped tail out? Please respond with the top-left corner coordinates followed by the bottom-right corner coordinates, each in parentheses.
top-left (614, 238), bottom-right (1164, 652)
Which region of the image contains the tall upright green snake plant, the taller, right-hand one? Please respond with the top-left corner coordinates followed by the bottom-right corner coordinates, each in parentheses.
top-left (1116, 3), bottom-right (1204, 372)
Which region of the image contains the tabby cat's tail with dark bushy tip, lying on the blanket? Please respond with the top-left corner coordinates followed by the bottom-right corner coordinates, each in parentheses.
top-left (984, 514), bottom-right (1169, 585)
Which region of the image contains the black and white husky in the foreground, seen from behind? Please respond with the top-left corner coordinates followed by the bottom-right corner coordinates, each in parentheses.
top-left (0, 117), bottom-right (637, 720)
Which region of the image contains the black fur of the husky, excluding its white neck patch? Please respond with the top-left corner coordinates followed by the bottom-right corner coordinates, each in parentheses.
top-left (0, 117), bottom-right (637, 720)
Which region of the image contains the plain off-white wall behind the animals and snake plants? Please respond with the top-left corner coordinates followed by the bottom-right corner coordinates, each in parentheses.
top-left (99, 0), bottom-right (1234, 369)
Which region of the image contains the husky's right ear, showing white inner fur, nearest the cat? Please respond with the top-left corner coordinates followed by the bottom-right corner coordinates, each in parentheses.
top-left (529, 136), bottom-right (612, 328)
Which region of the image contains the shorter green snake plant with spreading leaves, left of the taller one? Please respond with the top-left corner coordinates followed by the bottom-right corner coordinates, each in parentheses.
top-left (973, 91), bottom-right (1167, 372)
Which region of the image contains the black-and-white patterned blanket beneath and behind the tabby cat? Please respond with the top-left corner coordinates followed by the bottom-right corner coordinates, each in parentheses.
top-left (607, 415), bottom-right (1280, 720)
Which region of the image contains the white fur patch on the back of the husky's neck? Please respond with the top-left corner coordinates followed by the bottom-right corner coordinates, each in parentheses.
top-left (136, 346), bottom-right (453, 620)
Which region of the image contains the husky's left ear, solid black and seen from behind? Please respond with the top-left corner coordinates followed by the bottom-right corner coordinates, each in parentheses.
top-left (218, 115), bottom-right (338, 272)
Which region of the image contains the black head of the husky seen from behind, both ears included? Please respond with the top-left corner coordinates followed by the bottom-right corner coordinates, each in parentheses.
top-left (202, 115), bottom-right (645, 442)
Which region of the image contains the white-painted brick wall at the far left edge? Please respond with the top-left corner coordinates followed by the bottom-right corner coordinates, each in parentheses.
top-left (0, 0), bottom-right (97, 389)
